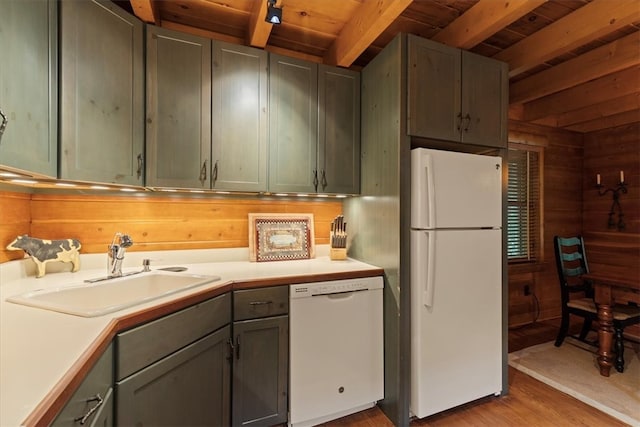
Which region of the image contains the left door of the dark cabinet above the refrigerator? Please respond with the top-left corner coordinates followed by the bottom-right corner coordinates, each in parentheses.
top-left (407, 35), bottom-right (462, 141)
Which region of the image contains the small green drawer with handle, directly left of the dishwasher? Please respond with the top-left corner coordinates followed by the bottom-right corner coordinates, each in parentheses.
top-left (233, 286), bottom-right (289, 321)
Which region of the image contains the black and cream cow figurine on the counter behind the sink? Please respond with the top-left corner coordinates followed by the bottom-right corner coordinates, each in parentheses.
top-left (7, 234), bottom-right (82, 277)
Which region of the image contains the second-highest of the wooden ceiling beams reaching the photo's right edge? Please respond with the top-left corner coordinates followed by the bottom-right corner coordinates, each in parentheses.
top-left (509, 31), bottom-right (640, 103)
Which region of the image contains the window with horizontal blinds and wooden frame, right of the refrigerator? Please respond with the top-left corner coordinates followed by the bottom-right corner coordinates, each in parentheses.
top-left (507, 148), bottom-right (542, 262)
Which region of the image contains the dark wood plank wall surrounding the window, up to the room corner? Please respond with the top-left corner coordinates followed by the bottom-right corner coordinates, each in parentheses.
top-left (509, 121), bottom-right (584, 326)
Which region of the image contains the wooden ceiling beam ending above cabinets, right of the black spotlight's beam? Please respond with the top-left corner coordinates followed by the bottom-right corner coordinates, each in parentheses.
top-left (324, 0), bottom-right (412, 67)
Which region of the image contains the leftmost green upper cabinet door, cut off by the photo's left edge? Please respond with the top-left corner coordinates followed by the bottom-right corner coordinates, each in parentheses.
top-left (0, 0), bottom-right (58, 177)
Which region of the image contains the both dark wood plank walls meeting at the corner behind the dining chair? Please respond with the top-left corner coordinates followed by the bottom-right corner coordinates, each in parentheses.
top-left (509, 122), bottom-right (640, 336)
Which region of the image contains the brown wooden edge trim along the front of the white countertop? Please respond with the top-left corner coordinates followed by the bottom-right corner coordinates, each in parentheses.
top-left (23, 268), bottom-right (384, 427)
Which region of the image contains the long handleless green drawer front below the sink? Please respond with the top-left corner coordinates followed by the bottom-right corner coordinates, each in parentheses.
top-left (116, 293), bottom-right (231, 381)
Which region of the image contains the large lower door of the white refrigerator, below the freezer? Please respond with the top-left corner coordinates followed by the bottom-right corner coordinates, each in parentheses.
top-left (411, 229), bottom-right (502, 418)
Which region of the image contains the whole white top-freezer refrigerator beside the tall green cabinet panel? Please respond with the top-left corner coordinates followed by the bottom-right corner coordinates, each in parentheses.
top-left (410, 148), bottom-right (502, 418)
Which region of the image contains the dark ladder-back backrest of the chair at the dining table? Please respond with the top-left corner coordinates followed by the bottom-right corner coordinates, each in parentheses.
top-left (553, 236), bottom-right (591, 299)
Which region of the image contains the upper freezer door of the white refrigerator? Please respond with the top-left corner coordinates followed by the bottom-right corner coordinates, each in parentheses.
top-left (411, 148), bottom-right (502, 230)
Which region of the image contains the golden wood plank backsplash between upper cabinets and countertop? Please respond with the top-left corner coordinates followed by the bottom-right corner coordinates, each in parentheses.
top-left (0, 191), bottom-right (342, 262)
